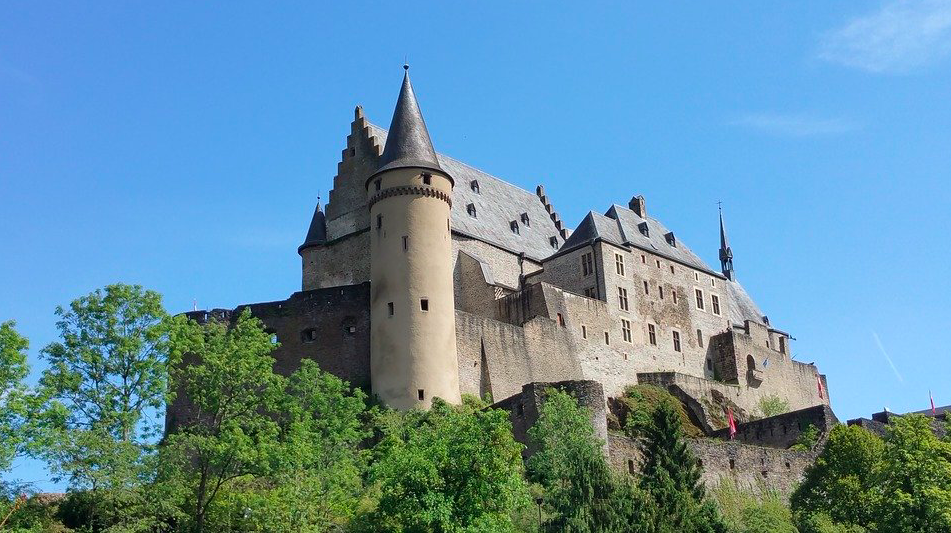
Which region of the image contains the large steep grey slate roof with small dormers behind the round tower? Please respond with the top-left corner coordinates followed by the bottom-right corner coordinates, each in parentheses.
top-left (369, 124), bottom-right (565, 262)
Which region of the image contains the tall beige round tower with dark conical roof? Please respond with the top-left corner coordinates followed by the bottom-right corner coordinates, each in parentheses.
top-left (366, 66), bottom-right (460, 409)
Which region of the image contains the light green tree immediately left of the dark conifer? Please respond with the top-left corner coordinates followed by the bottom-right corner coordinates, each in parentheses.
top-left (528, 389), bottom-right (653, 533)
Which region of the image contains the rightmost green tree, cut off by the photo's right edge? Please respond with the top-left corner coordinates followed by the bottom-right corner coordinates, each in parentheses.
top-left (876, 415), bottom-right (951, 533)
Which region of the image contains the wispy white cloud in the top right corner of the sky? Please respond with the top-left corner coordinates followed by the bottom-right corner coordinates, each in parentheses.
top-left (819, 0), bottom-right (951, 74)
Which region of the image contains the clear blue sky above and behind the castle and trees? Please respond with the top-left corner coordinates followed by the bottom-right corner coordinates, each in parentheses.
top-left (0, 1), bottom-right (951, 487)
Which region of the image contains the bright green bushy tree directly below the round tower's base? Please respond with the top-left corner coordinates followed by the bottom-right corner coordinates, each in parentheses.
top-left (362, 399), bottom-right (529, 532)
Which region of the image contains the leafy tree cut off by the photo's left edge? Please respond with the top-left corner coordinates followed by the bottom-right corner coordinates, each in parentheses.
top-left (0, 321), bottom-right (29, 472)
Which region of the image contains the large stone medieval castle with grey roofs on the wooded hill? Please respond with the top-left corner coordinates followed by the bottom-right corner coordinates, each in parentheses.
top-left (167, 67), bottom-right (834, 494)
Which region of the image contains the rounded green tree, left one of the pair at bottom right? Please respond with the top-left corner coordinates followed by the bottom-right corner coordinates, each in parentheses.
top-left (790, 425), bottom-right (885, 528)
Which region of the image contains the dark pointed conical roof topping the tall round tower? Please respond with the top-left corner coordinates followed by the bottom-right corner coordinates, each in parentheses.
top-left (368, 65), bottom-right (445, 181)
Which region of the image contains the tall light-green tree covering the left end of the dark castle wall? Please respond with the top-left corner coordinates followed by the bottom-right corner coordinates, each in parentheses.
top-left (161, 309), bottom-right (285, 533)
